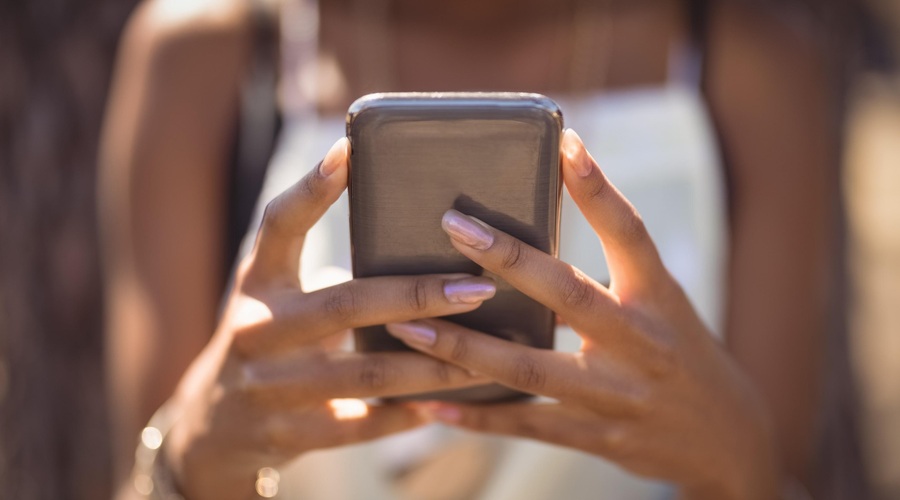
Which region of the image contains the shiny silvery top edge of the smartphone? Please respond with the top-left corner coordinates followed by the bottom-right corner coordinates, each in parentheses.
top-left (347, 92), bottom-right (563, 133)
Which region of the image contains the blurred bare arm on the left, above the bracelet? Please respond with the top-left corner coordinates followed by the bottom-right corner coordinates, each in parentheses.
top-left (98, 2), bottom-right (246, 480)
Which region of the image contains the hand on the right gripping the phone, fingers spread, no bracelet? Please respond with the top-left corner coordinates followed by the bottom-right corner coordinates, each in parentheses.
top-left (388, 131), bottom-right (777, 499)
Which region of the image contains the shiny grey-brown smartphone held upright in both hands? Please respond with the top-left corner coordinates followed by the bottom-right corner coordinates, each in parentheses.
top-left (347, 93), bottom-right (563, 402)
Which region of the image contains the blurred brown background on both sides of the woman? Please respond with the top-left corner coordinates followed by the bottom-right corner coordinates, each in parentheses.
top-left (0, 0), bottom-right (900, 499)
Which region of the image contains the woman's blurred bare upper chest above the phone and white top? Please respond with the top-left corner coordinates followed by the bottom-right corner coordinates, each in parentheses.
top-left (283, 0), bottom-right (684, 114)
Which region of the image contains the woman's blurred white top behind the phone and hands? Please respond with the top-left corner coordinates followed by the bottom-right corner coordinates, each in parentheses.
top-left (237, 1), bottom-right (727, 500)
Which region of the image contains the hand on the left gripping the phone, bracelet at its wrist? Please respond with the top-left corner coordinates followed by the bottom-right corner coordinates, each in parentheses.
top-left (162, 139), bottom-right (495, 499)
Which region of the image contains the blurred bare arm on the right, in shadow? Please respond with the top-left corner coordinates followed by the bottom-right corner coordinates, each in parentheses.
top-left (708, 2), bottom-right (839, 483)
